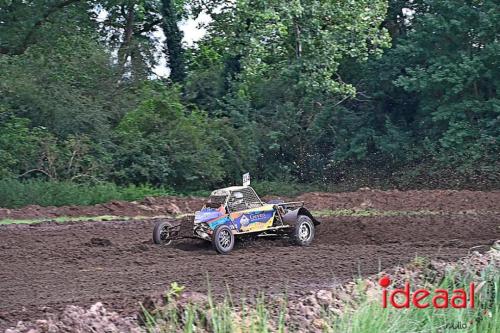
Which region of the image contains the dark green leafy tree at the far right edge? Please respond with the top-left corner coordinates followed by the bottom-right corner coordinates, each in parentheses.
top-left (395, 0), bottom-right (500, 171)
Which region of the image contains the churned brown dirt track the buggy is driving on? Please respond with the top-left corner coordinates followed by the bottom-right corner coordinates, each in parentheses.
top-left (0, 191), bottom-right (500, 328)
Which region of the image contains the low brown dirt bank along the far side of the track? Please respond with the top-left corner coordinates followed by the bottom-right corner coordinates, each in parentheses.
top-left (0, 189), bottom-right (500, 219)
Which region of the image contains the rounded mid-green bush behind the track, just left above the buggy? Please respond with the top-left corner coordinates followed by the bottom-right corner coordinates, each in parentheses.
top-left (114, 85), bottom-right (224, 188)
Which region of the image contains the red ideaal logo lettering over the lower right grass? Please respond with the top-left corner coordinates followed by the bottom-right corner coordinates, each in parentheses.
top-left (379, 276), bottom-right (475, 309)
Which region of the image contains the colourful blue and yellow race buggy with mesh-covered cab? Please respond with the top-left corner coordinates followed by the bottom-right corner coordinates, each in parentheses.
top-left (153, 178), bottom-right (319, 254)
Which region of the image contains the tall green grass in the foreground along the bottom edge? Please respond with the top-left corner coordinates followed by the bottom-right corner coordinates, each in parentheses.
top-left (144, 260), bottom-right (500, 333)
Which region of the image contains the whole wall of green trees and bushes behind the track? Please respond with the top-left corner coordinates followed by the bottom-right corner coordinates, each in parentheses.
top-left (0, 0), bottom-right (500, 190)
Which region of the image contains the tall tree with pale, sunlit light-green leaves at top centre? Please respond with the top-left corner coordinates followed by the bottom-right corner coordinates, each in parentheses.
top-left (191, 0), bottom-right (388, 179)
